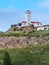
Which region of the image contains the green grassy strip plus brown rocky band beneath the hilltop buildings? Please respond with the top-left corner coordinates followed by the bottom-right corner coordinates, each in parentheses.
top-left (0, 30), bottom-right (49, 49)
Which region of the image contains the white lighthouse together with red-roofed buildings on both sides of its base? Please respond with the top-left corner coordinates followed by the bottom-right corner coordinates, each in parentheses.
top-left (21, 10), bottom-right (41, 27)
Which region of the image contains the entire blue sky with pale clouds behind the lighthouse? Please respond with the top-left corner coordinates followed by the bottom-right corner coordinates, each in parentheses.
top-left (0, 0), bottom-right (49, 31)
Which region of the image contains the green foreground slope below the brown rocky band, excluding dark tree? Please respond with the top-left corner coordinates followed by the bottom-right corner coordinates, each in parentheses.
top-left (0, 44), bottom-right (49, 65)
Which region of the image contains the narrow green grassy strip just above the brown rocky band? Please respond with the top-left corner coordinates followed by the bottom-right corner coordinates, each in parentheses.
top-left (0, 30), bottom-right (49, 37)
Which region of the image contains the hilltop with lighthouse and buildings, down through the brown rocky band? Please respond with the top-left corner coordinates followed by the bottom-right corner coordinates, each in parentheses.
top-left (0, 10), bottom-right (49, 48)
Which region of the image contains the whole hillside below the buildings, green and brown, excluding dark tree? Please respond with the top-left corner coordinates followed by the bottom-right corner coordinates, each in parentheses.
top-left (0, 30), bottom-right (49, 65)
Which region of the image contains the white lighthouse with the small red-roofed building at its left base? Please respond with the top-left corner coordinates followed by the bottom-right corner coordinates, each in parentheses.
top-left (21, 10), bottom-right (31, 27)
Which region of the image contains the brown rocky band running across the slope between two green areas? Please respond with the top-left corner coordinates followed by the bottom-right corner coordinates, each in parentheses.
top-left (0, 36), bottom-right (49, 49)
